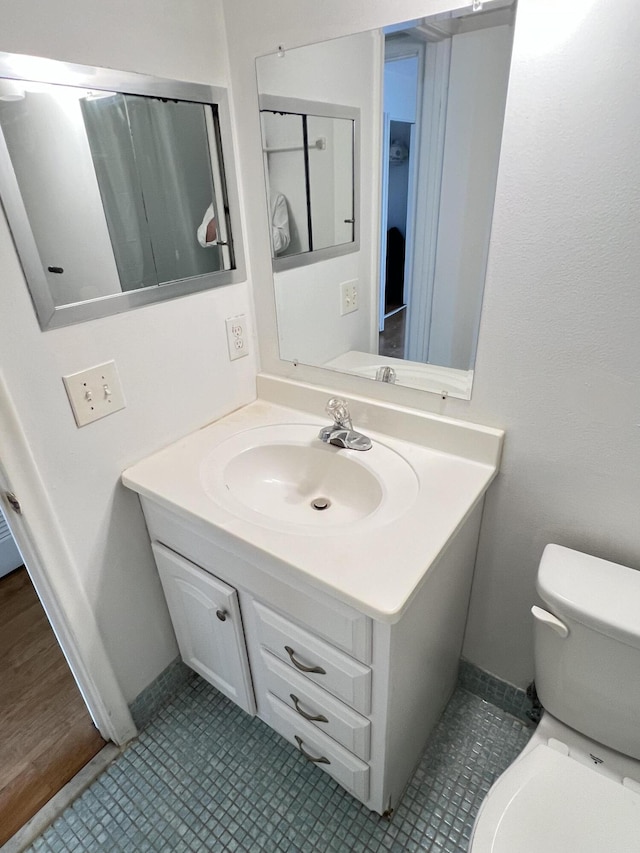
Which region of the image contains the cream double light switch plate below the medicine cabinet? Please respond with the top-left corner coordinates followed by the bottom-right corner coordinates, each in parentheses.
top-left (62, 361), bottom-right (125, 427)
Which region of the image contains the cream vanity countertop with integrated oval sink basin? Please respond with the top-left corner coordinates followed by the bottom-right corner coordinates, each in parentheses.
top-left (122, 392), bottom-right (503, 622)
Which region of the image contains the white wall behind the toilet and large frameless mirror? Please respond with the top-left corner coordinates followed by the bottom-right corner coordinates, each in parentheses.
top-left (223, 0), bottom-right (640, 686)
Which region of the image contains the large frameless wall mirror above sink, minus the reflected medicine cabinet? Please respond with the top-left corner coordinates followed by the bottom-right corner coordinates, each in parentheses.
top-left (257, 0), bottom-right (515, 399)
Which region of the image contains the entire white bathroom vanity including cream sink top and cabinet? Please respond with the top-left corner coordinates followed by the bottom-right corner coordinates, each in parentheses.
top-left (122, 392), bottom-right (503, 814)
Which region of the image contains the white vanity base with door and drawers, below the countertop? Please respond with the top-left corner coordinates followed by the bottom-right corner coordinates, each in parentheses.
top-left (142, 497), bottom-right (480, 814)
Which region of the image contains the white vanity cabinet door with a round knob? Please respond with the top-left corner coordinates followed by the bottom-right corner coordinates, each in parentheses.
top-left (152, 542), bottom-right (256, 715)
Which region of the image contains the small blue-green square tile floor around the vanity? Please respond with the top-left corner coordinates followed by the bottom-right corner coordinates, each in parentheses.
top-left (29, 678), bottom-right (531, 853)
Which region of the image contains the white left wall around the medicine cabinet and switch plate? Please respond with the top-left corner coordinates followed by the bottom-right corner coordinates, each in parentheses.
top-left (0, 0), bottom-right (256, 701)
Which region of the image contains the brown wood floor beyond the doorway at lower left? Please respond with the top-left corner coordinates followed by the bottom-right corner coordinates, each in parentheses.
top-left (0, 568), bottom-right (104, 845)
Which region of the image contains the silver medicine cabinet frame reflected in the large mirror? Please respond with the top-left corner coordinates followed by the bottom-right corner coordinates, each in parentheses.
top-left (258, 91), bottom-right (360, 272)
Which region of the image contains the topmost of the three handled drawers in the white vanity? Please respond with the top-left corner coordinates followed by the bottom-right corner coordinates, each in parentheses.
top-left (253, 601), bottom-right (371, 714)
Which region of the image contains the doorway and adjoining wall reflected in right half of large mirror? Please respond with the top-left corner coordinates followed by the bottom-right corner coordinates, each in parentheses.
top-left (380, 12), bottom-right (513, 372)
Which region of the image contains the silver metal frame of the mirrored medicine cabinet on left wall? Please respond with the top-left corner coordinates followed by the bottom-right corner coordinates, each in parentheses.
top-left (0, 52), bottom-right (246, 331)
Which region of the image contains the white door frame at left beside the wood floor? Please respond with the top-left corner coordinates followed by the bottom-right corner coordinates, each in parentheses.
top-left (0, 372), bottom-right (137, 745)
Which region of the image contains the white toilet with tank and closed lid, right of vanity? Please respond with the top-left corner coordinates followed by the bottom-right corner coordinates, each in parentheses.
top-left (469, 545), bottom-right (640, 853)
